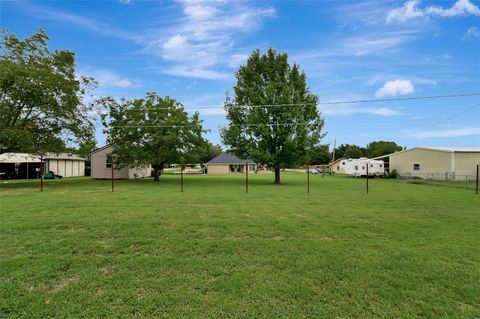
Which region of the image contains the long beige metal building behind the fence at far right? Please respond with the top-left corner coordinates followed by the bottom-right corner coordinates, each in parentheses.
top-left (375, 147), bottom-right (480, 180)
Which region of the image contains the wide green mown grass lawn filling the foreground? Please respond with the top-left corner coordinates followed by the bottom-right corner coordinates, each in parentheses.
top-left (0, 172), bottom-right (480, 318)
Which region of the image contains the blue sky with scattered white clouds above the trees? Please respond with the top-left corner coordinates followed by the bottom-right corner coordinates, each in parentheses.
top-left (0, 0), bottom-right (480, 147)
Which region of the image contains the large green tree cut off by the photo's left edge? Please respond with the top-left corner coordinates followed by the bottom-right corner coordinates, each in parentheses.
top-left (0, 30), bottom-right (95, 154)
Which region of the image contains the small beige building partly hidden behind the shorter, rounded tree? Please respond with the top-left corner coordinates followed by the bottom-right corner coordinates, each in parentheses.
top-left (90, 144), bottom-right (152, 179)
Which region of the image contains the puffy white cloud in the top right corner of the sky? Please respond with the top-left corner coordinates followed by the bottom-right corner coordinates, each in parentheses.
top-left (385, 0), bottom-right (480, 24)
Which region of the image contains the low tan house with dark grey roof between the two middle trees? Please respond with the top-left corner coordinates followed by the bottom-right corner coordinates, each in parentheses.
top-left (206, 153), bottom-right (269, 174)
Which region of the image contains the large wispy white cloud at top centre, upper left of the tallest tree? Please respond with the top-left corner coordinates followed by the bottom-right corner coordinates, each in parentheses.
top-left (144, 1), bottom-right (275, 79)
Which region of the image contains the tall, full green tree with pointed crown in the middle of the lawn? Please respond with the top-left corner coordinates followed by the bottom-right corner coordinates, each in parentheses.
top-left (221, 49), bottom-right (323, 184)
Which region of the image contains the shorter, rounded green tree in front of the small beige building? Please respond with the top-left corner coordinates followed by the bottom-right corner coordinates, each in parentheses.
top-left (98, 93), bottom-right (209, 181)
